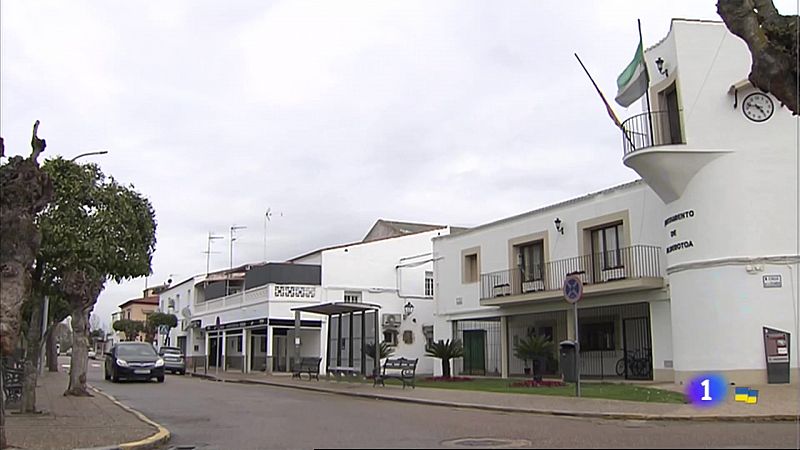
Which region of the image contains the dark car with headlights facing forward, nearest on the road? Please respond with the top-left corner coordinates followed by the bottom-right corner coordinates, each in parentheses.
top-left (104, 342), bottom-right (164, 383)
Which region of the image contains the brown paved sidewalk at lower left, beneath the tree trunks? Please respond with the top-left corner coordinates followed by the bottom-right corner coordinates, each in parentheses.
top-left (5, 372), bottom-right (159, 450)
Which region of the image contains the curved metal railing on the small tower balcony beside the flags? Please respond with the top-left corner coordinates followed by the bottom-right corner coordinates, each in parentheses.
top-left (622, 111), bottom-right (684, 155)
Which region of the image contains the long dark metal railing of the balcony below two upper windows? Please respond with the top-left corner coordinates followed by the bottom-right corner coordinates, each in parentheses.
top-left (481, 245), bottom-right (663, 299)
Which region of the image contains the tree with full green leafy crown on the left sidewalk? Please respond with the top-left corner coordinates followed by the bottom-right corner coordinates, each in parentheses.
top-left (37, 158), bottom-right (156, 395)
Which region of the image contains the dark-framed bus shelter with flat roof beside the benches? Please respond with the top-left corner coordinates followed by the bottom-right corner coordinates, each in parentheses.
top-left (292, 302), bottom-right (381, 375)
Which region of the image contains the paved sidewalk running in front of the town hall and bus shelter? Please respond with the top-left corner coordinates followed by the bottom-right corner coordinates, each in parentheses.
top-left (194, 373), bottom-right (800, 421)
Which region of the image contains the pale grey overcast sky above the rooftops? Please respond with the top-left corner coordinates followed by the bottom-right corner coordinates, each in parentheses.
top-left (0, 0), bottom-right (796, 326)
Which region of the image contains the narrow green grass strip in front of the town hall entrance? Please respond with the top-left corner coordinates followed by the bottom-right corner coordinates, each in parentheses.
top-left (387, 378), bottom-right (686, 403)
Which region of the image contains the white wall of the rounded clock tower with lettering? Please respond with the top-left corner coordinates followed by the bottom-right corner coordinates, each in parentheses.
top-left (645, 21), bottom-right (800, 383)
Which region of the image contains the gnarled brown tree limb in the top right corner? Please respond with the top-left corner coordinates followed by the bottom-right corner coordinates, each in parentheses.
top-left (717, 0), bottom-right (800, 115)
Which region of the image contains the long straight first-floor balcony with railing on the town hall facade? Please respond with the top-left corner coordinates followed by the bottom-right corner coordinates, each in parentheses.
top-left (481, 245), bottom-right (664, 306)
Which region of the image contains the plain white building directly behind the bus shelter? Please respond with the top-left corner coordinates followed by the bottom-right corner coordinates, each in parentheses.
top-left (290, 220), bottom-right (460, 374)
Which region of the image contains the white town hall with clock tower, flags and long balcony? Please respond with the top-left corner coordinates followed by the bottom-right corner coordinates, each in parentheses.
top-left (434, 19), bottom-right (800, 385)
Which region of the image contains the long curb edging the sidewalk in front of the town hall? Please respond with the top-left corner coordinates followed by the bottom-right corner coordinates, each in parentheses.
top-left (192, 374), bottom-right (798, 423)
